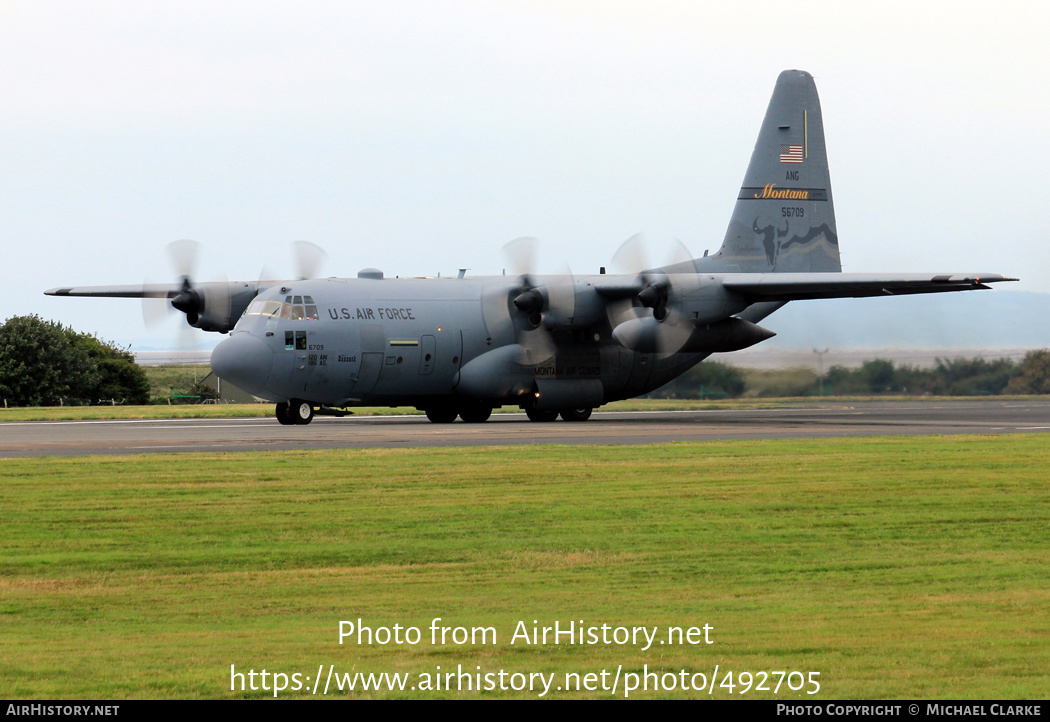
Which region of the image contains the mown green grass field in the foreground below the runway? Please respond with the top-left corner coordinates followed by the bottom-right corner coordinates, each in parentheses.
top-left (0, 434), bottom-right (1050, 699)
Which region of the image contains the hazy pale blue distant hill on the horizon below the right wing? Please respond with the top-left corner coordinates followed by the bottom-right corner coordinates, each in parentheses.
top-left (761, 291), bottom-right (1050, 349)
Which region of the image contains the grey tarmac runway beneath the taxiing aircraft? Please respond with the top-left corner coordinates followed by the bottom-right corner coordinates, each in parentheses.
top-left (0, 400), bottom-right (1050, 458)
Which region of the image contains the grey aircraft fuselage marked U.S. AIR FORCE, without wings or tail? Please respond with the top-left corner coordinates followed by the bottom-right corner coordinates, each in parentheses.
top-left (213, 276), bottom-right (707, 407)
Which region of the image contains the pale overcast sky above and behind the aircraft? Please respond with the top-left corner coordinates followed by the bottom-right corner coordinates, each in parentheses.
top-left (0, 0), bottom-right (1050, 346)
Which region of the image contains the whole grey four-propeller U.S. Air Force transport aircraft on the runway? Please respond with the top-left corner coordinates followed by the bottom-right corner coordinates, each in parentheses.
top-left (45, 70), bottom-right (1016, 424)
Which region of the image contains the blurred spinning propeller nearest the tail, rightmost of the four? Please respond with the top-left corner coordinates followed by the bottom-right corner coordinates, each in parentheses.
top-left (607, 233), bottom-right (699, 357)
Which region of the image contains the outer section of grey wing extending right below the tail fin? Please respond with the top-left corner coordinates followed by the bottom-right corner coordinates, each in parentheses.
top-left (721, 273), bottom-right (1017, 301)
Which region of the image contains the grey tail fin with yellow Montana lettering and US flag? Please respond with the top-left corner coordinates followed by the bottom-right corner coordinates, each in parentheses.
top-left (697, 70), bottom-right (842, 273)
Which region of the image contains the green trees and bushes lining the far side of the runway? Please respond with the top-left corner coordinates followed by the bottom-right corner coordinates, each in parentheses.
top-left (0, 315), bottom-right (1050, 406)
